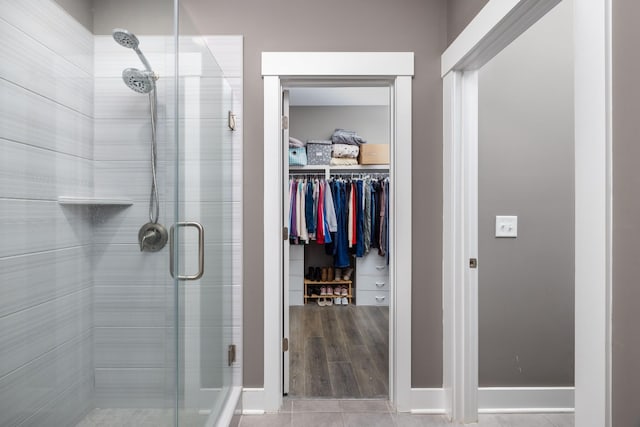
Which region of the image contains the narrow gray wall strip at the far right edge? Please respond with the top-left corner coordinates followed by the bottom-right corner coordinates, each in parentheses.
top-left (612, 0), bottom-right (640, 427)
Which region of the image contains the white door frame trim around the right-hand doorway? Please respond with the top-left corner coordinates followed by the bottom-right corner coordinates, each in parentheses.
top-left (442, 0), bottom-right (612, 427)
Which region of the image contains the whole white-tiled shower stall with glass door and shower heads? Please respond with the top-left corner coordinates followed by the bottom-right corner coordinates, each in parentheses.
top-left (0, 0), bottom-right (242, 427)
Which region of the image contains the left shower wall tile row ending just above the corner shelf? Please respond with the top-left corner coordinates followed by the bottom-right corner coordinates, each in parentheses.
top-left (0, 139), bottom-right (93, 200)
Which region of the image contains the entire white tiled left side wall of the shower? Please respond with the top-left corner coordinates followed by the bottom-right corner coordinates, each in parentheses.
top-left (0, 0), bottom-right (93, 426)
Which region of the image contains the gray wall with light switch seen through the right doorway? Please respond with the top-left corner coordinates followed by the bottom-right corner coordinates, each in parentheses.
top-left (478, 0), bottom-right (574, 387)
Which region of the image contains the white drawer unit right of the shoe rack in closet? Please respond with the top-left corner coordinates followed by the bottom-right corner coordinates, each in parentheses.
top-left (355, 249), bottom-right (389, 306)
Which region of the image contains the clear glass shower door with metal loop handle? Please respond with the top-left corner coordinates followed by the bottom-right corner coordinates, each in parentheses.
top-left (173, 17), bottom-right (234, 426)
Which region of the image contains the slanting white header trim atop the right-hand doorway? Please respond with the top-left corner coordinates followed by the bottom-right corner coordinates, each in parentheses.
top-left (441, 0), bottom-right (561, 77)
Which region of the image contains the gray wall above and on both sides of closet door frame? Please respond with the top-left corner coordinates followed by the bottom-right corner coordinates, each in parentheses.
top-left (184, 0), bottom-right (446, 387)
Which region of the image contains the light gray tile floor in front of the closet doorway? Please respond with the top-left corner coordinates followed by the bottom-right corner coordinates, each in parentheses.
top-left (240, 400), bottom-right (573, 427)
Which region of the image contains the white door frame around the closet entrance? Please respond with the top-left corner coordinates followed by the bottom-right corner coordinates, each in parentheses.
top-left (262, 52), bottom-right (413, 411)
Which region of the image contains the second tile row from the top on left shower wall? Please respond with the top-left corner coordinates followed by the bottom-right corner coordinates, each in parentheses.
top-left (0, 19), bottom-right (93, 116)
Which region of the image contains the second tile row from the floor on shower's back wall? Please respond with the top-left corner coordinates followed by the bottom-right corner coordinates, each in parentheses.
top-left (94, 327), bottom-right (175, 369)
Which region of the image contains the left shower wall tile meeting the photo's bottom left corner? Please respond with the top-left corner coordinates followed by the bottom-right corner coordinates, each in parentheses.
top-left (0, 332), bottom-right (93, 426)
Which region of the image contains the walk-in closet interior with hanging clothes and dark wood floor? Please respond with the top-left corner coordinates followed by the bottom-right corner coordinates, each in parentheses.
top-left (283, 84), bottom-right (391, 399)
